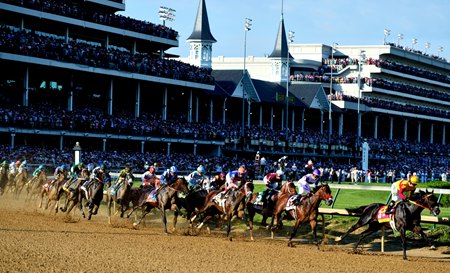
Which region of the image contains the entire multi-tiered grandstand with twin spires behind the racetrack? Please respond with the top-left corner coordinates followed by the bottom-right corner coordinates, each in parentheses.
top-left (0, 0), bottom-right (450, 177)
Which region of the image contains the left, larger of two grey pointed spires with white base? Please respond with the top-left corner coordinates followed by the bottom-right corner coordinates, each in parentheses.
top-left (187, 0), bottom-right (217, 68)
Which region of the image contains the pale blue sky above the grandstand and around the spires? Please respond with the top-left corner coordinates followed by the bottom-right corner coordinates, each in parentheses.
top-left (120, 0), bottom-right (450, 60)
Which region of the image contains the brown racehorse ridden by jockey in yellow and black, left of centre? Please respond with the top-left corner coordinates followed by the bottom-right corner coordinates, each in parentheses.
top-left (106, 173), bottom-right (134, 224)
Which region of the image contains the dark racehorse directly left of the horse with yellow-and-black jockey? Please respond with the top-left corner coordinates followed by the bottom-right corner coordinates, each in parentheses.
top-left (78, 173), bottom-right (111, 220)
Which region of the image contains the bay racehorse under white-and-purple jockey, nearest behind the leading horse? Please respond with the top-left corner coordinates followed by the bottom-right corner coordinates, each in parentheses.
top-left (272, 184), bottom-right (333, 248)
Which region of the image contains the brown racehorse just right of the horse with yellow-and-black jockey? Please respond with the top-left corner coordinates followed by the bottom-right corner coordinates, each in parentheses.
top-left (133, 177), bottom-right (189, 234)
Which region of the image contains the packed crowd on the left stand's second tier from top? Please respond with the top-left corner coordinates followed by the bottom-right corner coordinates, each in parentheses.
top-left (0, 26), bottom-right (214, 84)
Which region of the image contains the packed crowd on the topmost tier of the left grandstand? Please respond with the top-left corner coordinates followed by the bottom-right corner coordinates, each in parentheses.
top-left (0, 0), bottom-right (178, 40)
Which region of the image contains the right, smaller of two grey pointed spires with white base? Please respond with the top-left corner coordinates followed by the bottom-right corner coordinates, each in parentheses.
top-left (269, 1), bottom-right (292, 83)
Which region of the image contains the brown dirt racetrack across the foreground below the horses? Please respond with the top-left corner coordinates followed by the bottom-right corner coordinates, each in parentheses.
top-left (0, 191), bottom-right (450, 273)
